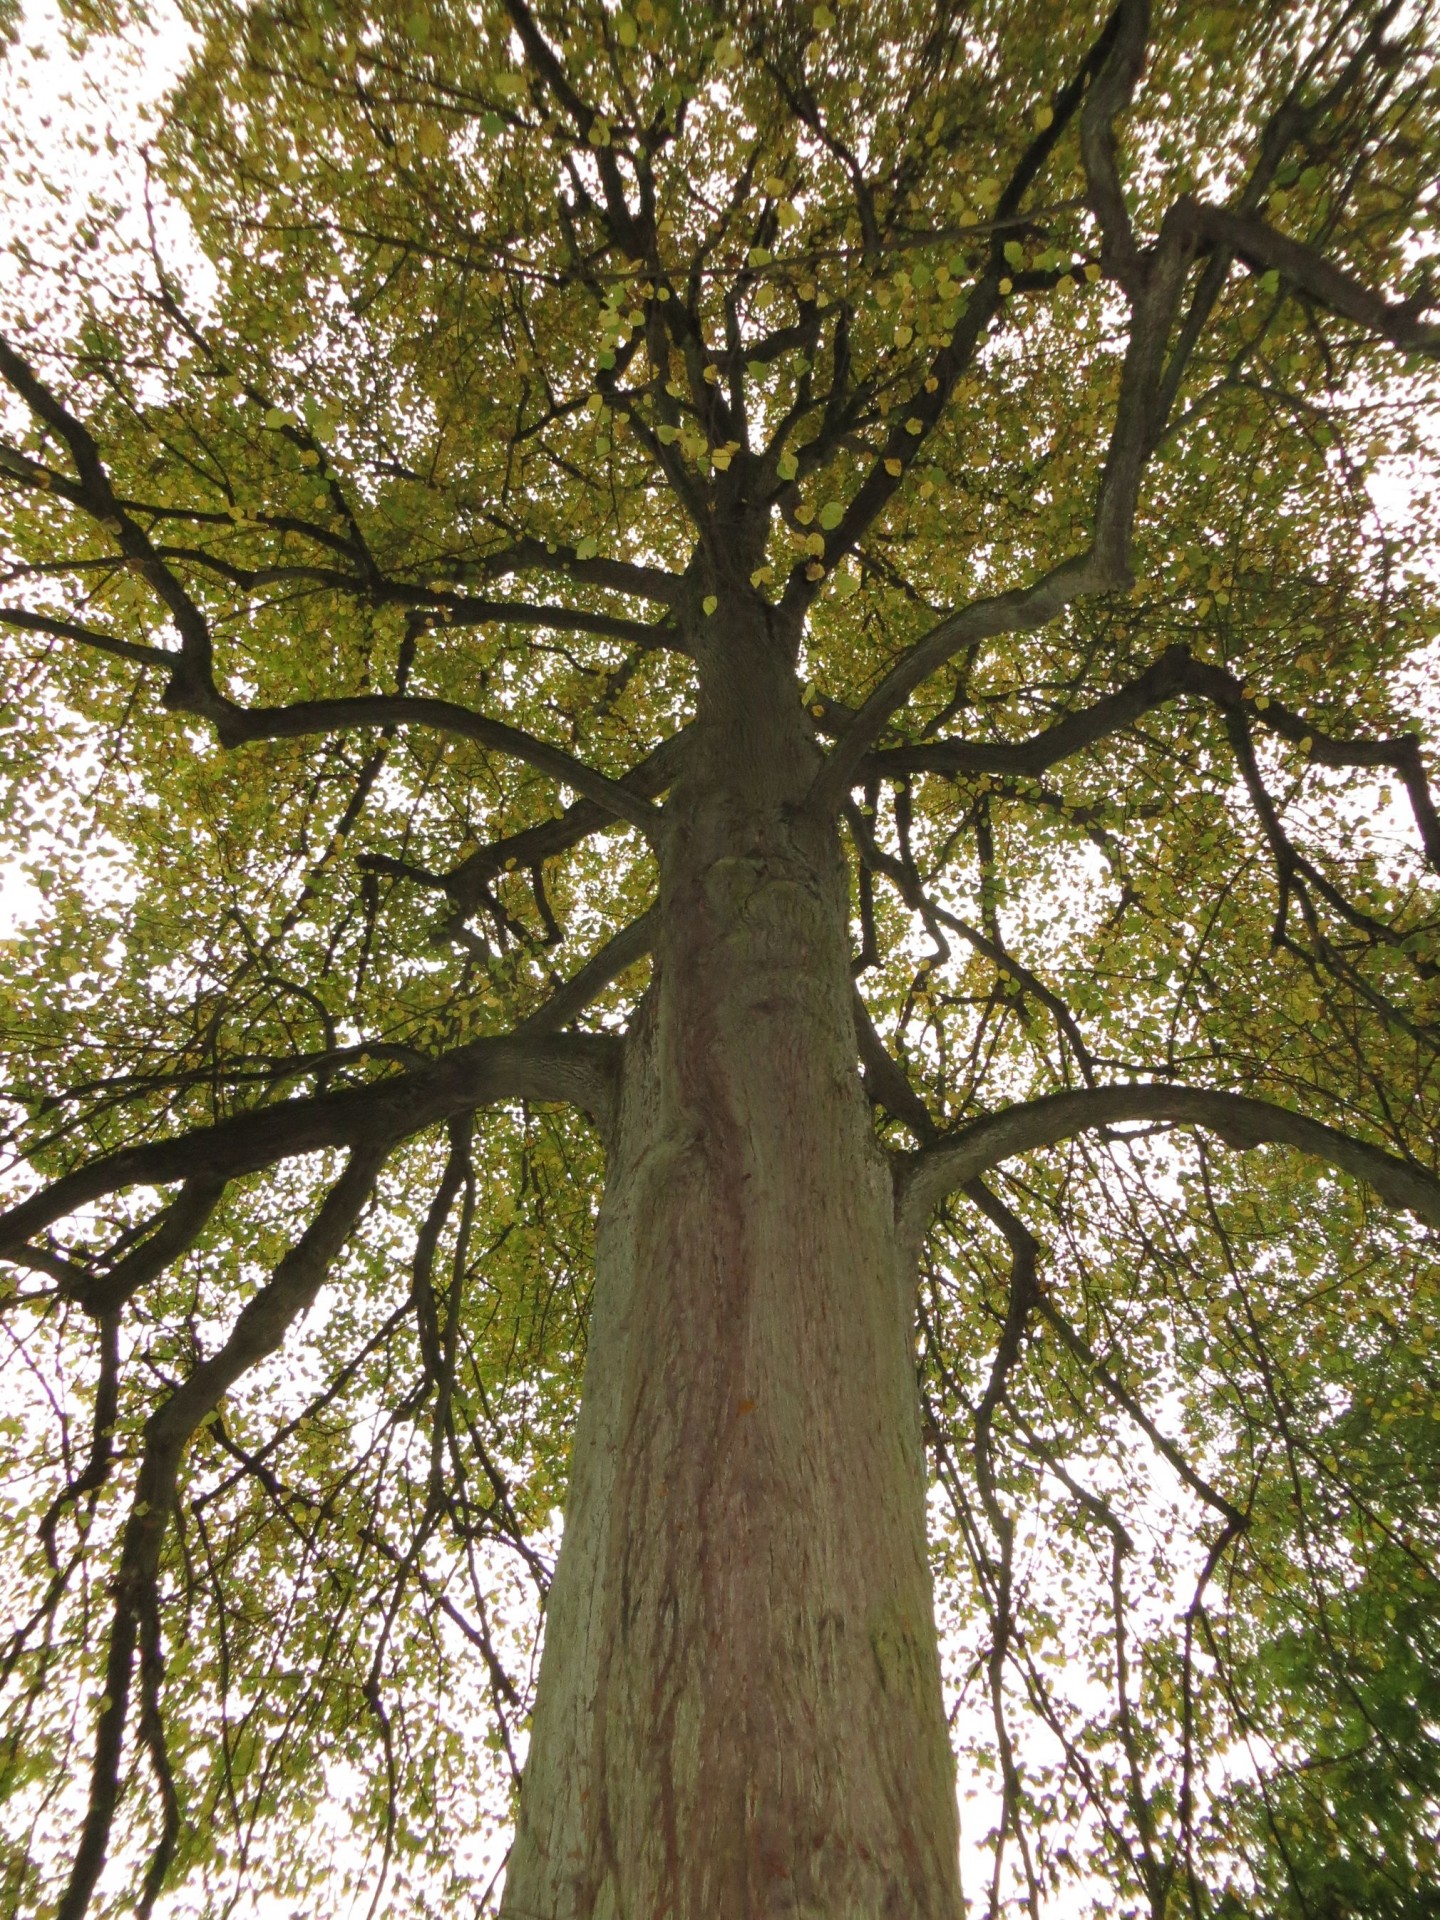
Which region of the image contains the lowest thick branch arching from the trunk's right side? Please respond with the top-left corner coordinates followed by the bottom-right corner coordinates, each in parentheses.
top-left (895, 1081), bottom-right (1440, 1238)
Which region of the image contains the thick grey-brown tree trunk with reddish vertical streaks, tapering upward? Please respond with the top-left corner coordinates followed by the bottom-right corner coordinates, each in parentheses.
top-left (503, 607), bottom-right (960, 1920)
